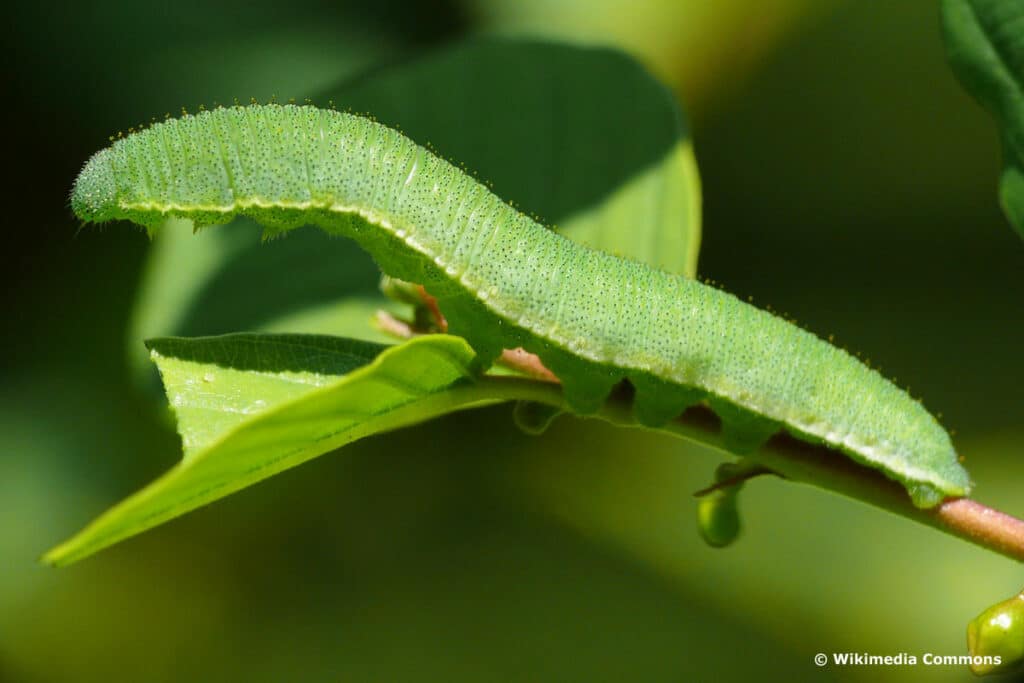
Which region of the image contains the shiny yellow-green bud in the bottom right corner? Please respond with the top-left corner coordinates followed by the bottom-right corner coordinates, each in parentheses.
top-left (967, 591), bottom-right (1024, 676)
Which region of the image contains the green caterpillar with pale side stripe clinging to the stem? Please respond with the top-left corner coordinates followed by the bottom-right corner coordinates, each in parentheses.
top-left (71, 104), bottom-right (971, 507)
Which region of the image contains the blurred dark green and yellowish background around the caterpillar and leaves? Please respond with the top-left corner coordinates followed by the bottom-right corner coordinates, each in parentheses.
top-left (0, 0), bottom-right (1024, 682)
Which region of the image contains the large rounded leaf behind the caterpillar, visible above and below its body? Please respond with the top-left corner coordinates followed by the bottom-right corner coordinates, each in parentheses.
top-left (129, 39), bottom-right (700, 373)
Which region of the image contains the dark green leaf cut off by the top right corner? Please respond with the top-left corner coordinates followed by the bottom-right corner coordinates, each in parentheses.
top-left (942, 0), bottom-right (1024, 237)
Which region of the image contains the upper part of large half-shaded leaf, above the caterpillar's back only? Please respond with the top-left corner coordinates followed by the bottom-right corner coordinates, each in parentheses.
top-left (331, 38), bottom-right (700, 276)
